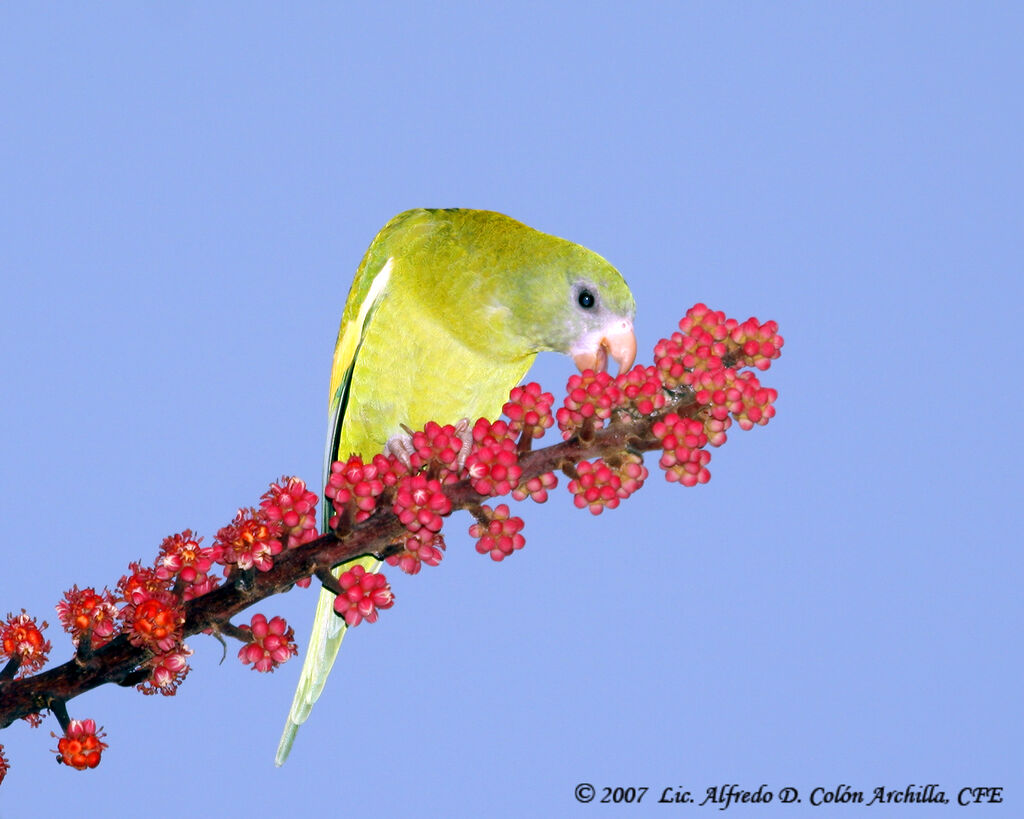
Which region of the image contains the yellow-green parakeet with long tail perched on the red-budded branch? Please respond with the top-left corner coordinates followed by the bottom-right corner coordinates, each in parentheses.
top-left (276, 209), bottom-right (636, 765)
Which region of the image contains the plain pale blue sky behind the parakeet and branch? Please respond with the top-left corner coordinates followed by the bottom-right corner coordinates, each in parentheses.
top-left (0, 3), bottom-right (1024, 818)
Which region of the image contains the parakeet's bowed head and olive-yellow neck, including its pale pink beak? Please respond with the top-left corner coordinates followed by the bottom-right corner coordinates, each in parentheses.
top-left (398, 209), bottom-right (636, 372)
